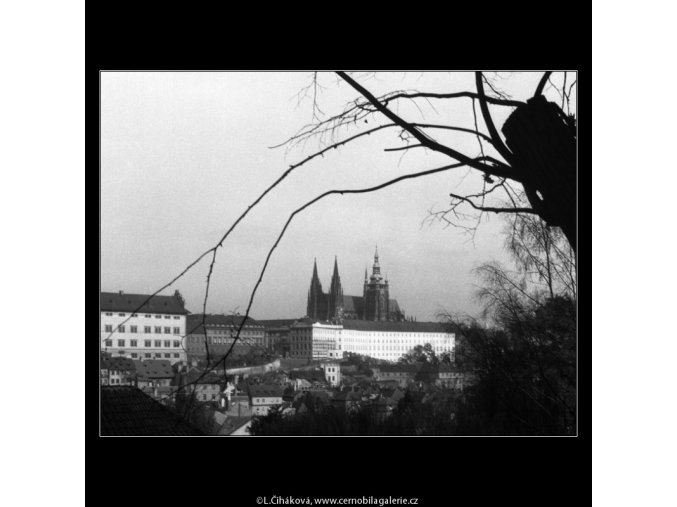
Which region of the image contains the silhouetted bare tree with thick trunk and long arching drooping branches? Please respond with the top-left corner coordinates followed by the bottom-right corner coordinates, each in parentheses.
top-left (100, 72), bottom-right (576, 424)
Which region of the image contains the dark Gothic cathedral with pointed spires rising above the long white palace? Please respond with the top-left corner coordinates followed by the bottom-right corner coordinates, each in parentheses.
top-left (306, 248), bottom-right (405, 322)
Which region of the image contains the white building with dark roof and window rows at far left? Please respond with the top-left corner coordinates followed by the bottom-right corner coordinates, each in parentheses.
top-left (100, 291), bottom-right (188, 364)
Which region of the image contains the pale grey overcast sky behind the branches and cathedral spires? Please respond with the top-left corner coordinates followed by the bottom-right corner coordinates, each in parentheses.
top-left (101, 72), bottom-right (561, 321)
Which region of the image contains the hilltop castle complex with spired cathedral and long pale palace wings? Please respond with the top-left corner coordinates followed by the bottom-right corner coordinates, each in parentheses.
top-left (100, 249), bottom-right (455, 368)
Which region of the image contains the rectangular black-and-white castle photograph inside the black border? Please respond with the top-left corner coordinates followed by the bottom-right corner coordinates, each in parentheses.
top-left (99, 69), bottom-right (578, 437)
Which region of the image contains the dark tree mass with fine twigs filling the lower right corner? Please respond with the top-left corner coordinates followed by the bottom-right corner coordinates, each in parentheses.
top-left (438, 206), bottom-right (576, 434)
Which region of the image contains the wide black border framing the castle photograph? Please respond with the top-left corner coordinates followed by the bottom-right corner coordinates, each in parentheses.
top-left (85, 9), bottom-right (591, 506)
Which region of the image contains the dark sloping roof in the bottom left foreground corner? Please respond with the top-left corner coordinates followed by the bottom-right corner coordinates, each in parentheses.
top-left (101, 386), bottom-right (204, 436)
